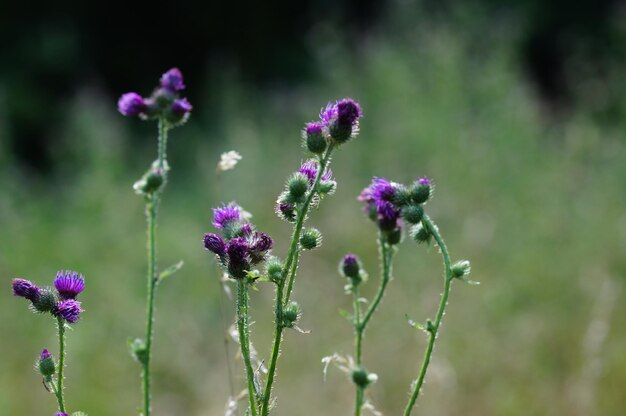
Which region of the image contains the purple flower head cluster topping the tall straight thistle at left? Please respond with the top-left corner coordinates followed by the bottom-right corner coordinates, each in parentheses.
top-left (117, 68), bottom-right (192, 127)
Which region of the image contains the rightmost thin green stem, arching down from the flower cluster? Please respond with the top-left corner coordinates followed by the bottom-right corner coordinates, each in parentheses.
top-left (404, 215), bottom-right (453, 416)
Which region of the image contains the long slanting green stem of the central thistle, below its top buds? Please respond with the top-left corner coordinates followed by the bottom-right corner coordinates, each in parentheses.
top-left (261, 144), bottom-right (334, 416)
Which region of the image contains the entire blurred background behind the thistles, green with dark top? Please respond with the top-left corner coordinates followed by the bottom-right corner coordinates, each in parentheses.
top-left (0, 0), bottom-right (626, 416)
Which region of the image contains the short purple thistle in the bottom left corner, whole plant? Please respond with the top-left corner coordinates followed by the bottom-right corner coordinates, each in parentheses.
top-left (12, 270), bottom-right (85, 416)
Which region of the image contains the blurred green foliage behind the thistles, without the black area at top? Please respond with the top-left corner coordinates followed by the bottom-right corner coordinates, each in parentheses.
top-left (0, 3), bottom-right (626, 416)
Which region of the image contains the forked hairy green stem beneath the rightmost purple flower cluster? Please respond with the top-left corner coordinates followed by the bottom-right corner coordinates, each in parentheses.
top-left (353, 232), bottom-right (394, 416)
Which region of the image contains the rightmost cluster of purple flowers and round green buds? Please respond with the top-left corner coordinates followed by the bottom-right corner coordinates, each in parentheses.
top-left (358, 177), bottom-right (433, 244)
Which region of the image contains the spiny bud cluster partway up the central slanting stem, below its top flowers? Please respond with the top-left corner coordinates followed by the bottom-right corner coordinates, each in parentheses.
top-left (276, 159), bottom-right (337, 224)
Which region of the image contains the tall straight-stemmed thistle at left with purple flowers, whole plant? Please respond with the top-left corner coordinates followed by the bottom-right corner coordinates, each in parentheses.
top-left (117, 68), bottom-right (192, 416)
